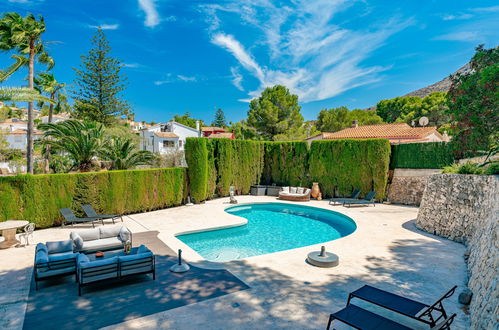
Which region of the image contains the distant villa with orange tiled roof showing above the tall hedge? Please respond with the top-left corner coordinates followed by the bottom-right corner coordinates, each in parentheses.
top-left (305, 122), bottom-right (449, 144)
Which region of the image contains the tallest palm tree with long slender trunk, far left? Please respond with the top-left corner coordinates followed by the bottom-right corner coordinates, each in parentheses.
top-left (0, 13), bottom-right (54, 174)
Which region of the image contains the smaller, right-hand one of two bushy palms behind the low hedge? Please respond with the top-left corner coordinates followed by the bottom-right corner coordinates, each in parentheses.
top-left (101, 137), bottom-right (154, 170)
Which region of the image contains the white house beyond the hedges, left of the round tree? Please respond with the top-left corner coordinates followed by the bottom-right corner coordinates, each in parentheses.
top-left (140, 121), bottom-right (201, 154)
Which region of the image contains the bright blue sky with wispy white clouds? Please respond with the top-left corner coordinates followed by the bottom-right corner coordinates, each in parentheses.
top-left (0, 0), bottom-right (499, 122)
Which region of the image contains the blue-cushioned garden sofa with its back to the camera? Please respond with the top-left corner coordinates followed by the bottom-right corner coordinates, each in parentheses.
top-left (77, 245), bottom-right (156, 296)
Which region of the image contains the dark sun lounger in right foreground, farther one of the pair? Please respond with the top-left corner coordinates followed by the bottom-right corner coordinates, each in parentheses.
top-left (347, 285), bottom-right (457, 327)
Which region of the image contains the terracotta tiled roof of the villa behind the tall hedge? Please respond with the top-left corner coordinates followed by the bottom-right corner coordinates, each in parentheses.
top-left (308, 123), bottom-right (443, 140)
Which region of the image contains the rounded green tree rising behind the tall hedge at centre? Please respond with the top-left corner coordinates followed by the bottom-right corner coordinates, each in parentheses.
top-left (247, 85), bottom-right (303, 140)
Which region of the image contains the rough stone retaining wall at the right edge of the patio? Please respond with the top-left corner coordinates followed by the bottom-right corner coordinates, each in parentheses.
top-left (416, 174), bottom-right (499, 329)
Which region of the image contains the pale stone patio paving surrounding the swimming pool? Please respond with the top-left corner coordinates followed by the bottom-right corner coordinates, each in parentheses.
top-left (0, 196), bottom-right (469, 329)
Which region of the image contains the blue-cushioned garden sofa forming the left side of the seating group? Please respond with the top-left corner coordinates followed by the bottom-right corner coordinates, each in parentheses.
top-left (33, 240), bottom-right (78, 290)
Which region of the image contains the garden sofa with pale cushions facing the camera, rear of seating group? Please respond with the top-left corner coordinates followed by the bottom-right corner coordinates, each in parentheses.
top-left (70, 226), bottom-right (132, 253)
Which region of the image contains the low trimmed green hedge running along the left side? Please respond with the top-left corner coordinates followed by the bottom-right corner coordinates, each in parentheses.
top-left (0, 168), bottom-right (186, 228)
